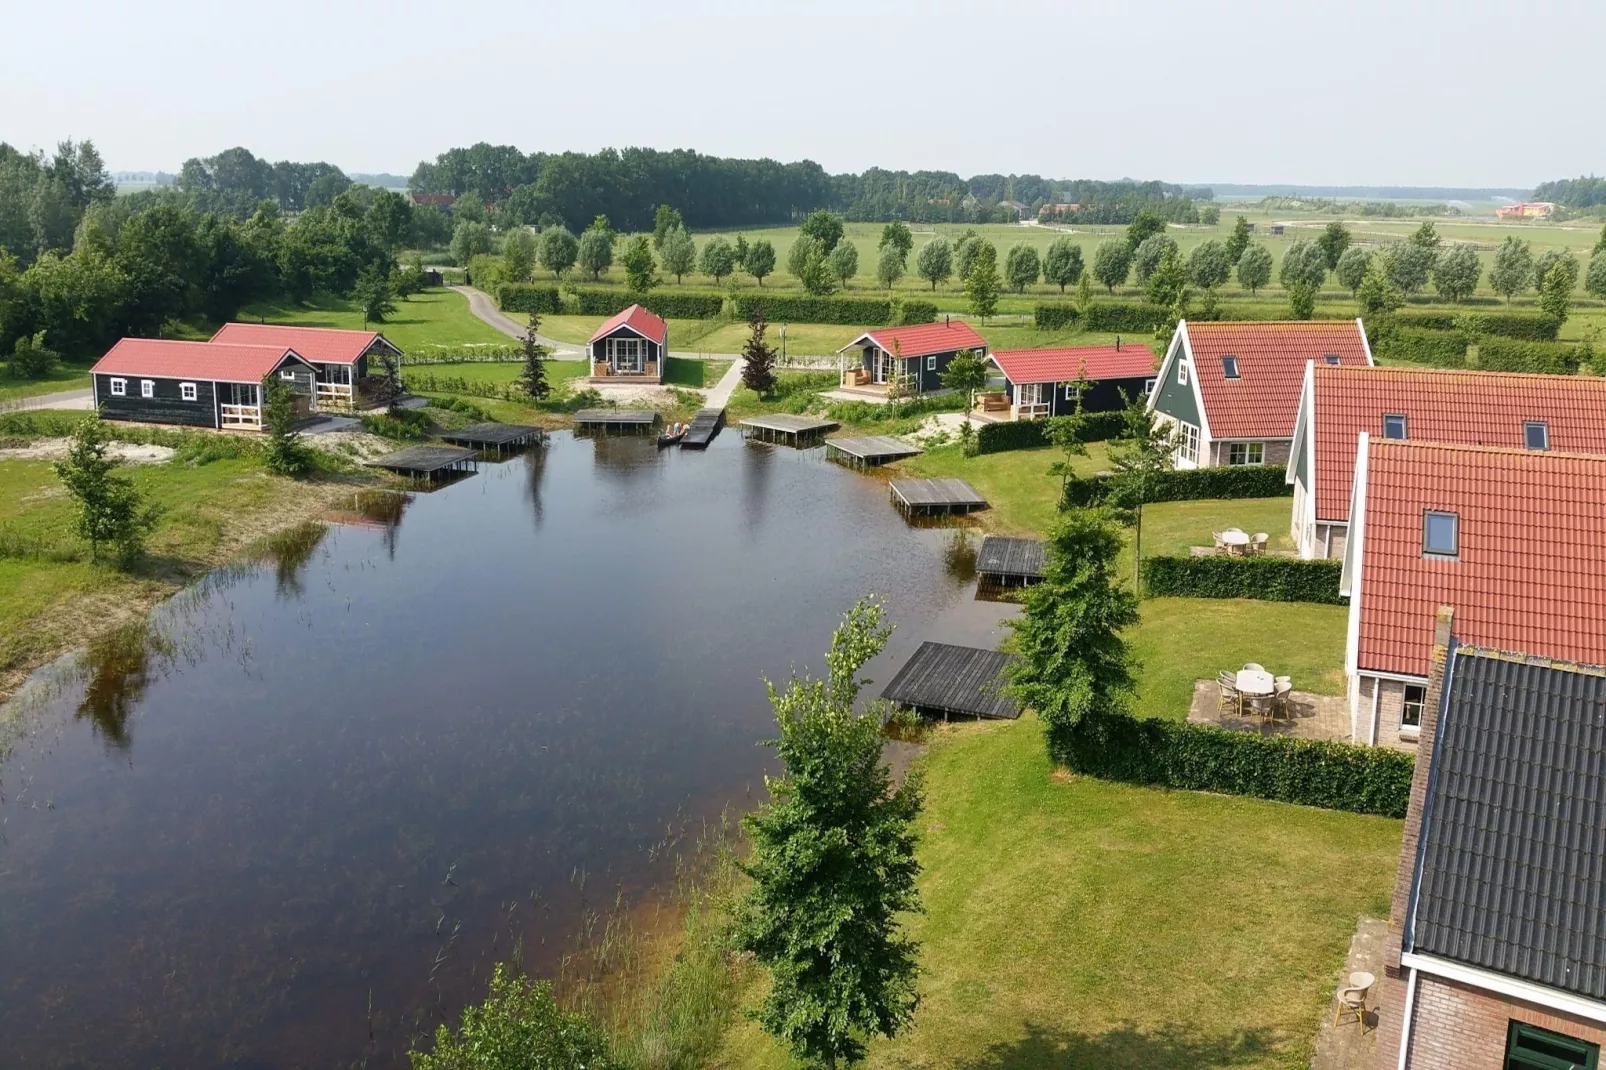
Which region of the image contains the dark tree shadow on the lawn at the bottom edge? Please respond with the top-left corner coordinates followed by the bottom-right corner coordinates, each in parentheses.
top-left (960, 1022), bottom-right (1278, 1070)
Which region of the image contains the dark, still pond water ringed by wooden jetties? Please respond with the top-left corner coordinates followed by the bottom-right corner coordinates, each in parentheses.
top-left (0, 432), bottom-right (1009, 1068)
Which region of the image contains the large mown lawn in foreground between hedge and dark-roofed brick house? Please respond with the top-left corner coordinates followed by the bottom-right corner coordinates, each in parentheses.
top-left (716, 706), bottom-right (1402, 1070)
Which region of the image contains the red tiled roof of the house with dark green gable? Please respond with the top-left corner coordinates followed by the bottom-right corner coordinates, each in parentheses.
top-left (1185, 320), bottom-right (1368, 439)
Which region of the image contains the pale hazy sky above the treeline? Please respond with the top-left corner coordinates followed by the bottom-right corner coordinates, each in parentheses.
top-left (0, 0), bottom-right (1606, 188)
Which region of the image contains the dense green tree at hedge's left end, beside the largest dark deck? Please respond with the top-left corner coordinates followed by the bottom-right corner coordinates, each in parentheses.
top-left (1009, 509), bottom-right (1137, 762)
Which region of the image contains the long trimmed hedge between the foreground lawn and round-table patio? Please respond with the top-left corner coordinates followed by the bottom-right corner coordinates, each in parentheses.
top-left (1054, 715), bottom-right (1416, 818)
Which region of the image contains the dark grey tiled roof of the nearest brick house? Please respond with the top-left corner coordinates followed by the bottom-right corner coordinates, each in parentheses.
top-left (1405, 647), bottom-right (1606, 999)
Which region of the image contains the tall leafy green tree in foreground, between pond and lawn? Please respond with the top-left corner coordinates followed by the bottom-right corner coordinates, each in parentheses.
top-left (736, 601), bottom-right (922, 1070)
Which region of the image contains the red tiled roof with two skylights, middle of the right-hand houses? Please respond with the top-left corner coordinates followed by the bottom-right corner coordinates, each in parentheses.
top-left (1312, 363), bottom-right (1606, 521)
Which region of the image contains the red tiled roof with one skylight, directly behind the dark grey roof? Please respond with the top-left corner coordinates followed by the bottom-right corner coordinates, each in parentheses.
top-left (1357, 439), bottom-right (1606, 676)
